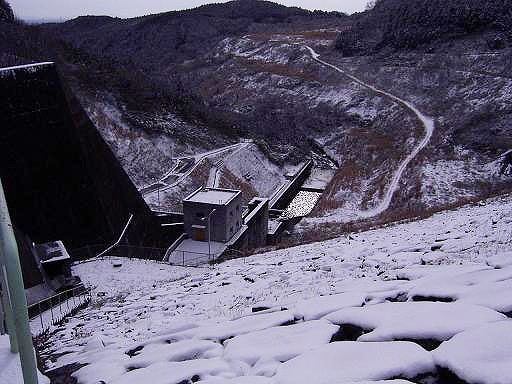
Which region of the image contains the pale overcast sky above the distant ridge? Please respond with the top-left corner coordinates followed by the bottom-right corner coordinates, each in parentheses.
top-left (9, 0), bottom-right (368, 20)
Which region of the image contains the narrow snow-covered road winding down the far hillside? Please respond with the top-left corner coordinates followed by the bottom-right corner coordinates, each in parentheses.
top-left (306, 46), bottom-right (435, 218)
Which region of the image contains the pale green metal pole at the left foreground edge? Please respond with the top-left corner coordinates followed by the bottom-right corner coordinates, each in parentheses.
top-left (0, 180), bottom-right (38, 384)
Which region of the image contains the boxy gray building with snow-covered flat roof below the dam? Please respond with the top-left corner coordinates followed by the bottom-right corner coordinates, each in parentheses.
top-left (183, 188), bottom-right (243, 243)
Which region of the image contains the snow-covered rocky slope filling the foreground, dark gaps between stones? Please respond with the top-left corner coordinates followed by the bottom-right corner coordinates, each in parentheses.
top-left (42, 196), bottom-right (512, 384)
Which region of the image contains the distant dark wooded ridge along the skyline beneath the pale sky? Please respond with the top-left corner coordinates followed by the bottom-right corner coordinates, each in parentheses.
top-left (43, 0), bottom-right (345, 70)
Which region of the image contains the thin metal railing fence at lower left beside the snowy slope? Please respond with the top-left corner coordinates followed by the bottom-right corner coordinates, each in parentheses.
top-left (28, 286), bottom-right (91, 336)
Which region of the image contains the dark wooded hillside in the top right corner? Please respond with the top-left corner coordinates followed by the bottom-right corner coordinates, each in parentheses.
top-left (336, 0), bottom-right (512, 56)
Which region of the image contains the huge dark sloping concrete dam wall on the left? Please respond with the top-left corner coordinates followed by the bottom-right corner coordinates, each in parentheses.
top-left (0, 63), bottom-right (183, 264)
